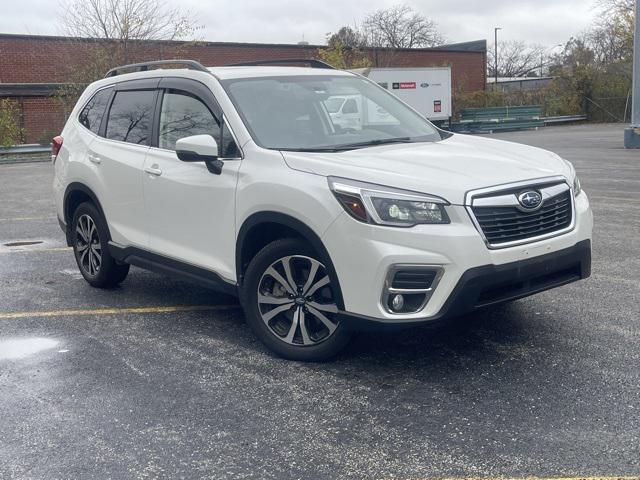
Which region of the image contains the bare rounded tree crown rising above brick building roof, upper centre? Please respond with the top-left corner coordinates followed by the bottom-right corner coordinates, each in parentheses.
top-left (362, 5), bottom-right (443, 49)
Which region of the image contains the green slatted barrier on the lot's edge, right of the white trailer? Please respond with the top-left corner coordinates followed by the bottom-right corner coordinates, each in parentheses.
top-left (451, 105), bottom-right (544, 133)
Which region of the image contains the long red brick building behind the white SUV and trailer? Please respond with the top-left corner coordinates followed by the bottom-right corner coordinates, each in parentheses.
top-left (0, 34), bottom-right (486, 143)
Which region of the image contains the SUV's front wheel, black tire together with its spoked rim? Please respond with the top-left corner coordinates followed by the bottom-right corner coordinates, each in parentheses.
top-left (240, 238), bottom-right (352, 362)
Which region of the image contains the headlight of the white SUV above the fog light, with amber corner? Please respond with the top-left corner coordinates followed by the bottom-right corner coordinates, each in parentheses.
top-left (329, 177), bottom-right (451, 227)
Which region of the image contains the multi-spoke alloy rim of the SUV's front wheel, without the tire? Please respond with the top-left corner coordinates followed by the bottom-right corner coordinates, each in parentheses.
top-left (258, 255), bottom-right (338, 346)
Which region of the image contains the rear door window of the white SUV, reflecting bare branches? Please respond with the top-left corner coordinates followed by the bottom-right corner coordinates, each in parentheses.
top-left (107, 90), bottom-right (156, 145)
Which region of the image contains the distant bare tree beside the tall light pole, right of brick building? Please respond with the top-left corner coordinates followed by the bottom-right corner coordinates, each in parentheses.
top-left (487, 40), bottom-right (550, 77)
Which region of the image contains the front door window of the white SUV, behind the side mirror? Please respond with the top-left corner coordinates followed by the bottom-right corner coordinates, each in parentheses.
top-left (158, 91), bottom-right (220, 150)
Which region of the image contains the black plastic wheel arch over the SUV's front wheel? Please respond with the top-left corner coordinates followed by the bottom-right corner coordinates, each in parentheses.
top-left (236, 212), bottom-right (344, 310)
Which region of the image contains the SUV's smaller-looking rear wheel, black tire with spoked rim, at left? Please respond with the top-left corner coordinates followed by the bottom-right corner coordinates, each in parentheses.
top-left (71, 202), bottom-right (129, 288)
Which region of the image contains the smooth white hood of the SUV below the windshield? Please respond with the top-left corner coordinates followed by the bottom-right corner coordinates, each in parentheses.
top-left (282, 134), bottom-right (571, 205)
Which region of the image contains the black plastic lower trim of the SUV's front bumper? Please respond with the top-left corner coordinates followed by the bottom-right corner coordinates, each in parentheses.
top-left (338, 240), bottom-right (591, 330)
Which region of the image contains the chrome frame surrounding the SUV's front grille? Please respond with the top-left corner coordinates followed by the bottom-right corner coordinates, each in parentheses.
top-left (464, 175), bottom-right (576, 250)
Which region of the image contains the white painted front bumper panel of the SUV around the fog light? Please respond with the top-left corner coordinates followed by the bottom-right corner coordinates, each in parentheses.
top-left (322, 192), bottom-right (593, 325)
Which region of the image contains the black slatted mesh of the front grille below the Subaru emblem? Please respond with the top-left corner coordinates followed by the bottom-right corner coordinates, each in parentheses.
top-left (472, 189), bottom-right (573, 245)
